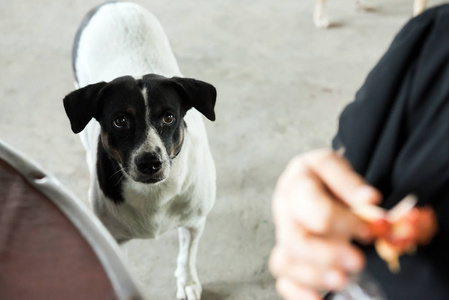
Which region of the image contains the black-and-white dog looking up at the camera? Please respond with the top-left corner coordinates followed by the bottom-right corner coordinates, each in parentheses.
top-left (64, 2), bottom-right (216, 300)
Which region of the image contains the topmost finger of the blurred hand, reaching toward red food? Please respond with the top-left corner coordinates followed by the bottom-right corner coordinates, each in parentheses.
top-left (301, 150), bottom-right (382, 204)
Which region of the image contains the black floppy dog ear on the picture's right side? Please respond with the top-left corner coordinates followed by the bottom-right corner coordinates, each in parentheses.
top-left (171, 77), bottom-right (217, 121)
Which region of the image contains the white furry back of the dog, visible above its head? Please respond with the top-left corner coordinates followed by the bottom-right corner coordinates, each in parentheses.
top-left (75, 2), bottom-right (181, 87)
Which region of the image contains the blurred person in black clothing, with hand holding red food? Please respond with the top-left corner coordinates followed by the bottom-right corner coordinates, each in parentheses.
top-left (270, 5), bottom-right (449, 300)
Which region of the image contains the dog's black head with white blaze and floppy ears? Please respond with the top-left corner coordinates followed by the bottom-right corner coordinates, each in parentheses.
top-left (64, 74), bottom-right (217, 183)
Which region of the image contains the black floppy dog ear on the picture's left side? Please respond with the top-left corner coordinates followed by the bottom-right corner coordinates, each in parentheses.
top-left (63, 81), bottom-right (107, 133)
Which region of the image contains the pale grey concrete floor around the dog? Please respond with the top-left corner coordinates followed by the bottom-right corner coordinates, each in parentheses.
top-left (0, 0), bottom-right (443, 300)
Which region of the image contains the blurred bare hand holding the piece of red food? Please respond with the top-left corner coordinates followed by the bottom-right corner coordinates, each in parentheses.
top-left (269, 150), bottom-right (381, 300)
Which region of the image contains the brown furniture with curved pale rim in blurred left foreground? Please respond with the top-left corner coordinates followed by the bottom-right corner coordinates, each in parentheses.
top-left (0, 141), bottom-right (142, 300)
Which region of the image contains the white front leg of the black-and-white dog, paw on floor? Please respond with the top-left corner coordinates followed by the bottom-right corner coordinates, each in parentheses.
top-left (175, 218), bottom-right (206, 300)
